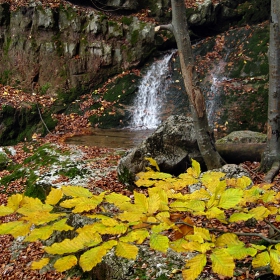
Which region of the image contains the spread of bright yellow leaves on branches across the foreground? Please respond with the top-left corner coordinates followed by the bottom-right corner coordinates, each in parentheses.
top-left (0, 158), bottom-right (280, 279)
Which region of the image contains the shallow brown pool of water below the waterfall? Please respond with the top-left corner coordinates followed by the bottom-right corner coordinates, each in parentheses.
top-left (66, 129), bottom-right (153, 149)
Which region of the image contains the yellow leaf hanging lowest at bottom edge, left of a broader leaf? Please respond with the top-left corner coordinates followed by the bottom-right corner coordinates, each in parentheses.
top-left (182, 254), bottom-right (207, 280)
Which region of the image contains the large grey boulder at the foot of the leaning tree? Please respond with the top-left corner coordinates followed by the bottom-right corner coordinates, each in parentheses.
top-left (118, 116), bottom-right (202, 183)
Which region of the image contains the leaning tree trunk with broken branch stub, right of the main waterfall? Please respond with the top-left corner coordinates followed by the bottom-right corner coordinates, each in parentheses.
top-left (156, 0), bottom-right (225, 169)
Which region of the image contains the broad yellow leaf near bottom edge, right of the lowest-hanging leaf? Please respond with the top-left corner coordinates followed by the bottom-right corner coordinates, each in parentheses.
top-left (210, 249), bottom-right (235, 277)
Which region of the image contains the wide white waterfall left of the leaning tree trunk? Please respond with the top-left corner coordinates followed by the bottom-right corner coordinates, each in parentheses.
top-left (130, 52), bottom-right (173, 130)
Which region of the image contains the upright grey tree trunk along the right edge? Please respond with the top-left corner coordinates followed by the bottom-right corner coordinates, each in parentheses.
top-left (261, 0), bottom-right (280, 182)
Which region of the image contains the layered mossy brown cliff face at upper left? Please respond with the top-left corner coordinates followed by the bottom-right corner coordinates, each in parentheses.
top-left (0, 4), bottom-right (154, 92)
